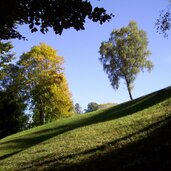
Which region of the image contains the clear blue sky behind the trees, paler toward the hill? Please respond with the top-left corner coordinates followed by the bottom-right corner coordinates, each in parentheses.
top-left (12, 0), bottom-right (171, 109)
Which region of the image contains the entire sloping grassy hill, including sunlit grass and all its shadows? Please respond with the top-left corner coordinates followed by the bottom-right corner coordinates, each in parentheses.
top-left (0, 87), bottom-right (171, 171)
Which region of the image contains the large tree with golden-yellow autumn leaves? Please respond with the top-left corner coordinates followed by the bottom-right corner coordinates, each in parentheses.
top-left (18, 43), bottom-right (73, 124)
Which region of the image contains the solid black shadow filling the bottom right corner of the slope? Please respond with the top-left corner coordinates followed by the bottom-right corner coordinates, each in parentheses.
top-left (64, 116), bottom-right (171, 171)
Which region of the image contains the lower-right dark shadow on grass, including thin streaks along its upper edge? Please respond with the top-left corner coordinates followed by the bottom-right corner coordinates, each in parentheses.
top-left (12, 117), bottom-right (171, 171)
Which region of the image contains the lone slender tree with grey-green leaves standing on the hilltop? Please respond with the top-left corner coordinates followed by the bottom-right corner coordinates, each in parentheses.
top-left (99, 21), bottom-right (153, 100)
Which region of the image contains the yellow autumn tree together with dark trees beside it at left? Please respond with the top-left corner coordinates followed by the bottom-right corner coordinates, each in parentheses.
top-left (0, 42), bottom-right (73, 137)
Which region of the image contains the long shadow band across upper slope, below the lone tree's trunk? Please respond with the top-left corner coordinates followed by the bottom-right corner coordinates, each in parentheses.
top-left (0, 87), bottom-right (171, 160)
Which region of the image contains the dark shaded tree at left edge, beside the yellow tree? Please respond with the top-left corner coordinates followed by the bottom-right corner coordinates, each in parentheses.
top-left (0, 42), bottom-right (29, 138)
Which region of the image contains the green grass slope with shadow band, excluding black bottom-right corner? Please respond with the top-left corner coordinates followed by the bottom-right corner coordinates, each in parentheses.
top-left (0, 87), bottom-right (171, 171)
